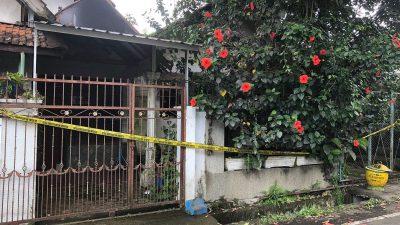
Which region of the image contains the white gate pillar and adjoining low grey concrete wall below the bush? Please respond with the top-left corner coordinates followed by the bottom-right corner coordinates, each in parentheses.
top-left (183, 107), bottom-right (329, 201)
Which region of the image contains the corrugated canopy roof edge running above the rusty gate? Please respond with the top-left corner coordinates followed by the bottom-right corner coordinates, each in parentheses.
top-left (35, 22), bottom-right (201, 51)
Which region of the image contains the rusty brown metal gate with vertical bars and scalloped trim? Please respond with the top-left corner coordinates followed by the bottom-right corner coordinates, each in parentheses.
top-left (0, 76), bottom-right (185, 223)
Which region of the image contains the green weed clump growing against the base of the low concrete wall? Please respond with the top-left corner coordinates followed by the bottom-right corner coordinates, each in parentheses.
top-left (261, 182), bottom-right (296, 206)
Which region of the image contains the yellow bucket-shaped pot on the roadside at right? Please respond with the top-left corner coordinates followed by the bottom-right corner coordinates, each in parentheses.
top-left (365, 164), bottom-right (391, 187)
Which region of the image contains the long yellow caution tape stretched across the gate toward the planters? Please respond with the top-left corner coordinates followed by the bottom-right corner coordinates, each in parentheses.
top-left (0, 109), bottom-right (309, 155)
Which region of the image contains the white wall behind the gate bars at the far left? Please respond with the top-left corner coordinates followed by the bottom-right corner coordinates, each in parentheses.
top-left (0, 109), bottom-right (36, 223)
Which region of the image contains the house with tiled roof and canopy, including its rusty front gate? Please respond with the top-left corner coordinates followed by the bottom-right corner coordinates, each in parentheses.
top-left (0, 0), bottom-right (199, 223)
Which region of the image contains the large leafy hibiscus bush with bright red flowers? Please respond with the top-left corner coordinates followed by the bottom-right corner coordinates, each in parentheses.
top-left (150, 0), bottom-right (400, 163)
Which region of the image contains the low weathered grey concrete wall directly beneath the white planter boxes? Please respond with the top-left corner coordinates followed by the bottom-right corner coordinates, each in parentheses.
top-left (204, 165), bottom-right (329, 201)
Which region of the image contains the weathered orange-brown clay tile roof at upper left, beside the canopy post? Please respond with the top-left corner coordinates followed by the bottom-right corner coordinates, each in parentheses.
top-left (0, 23), bottom-right (49, 48)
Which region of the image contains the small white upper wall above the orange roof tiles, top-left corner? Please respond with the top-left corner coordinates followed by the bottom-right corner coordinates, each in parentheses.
top-left (0, 0), bottom-right (21, 24)
